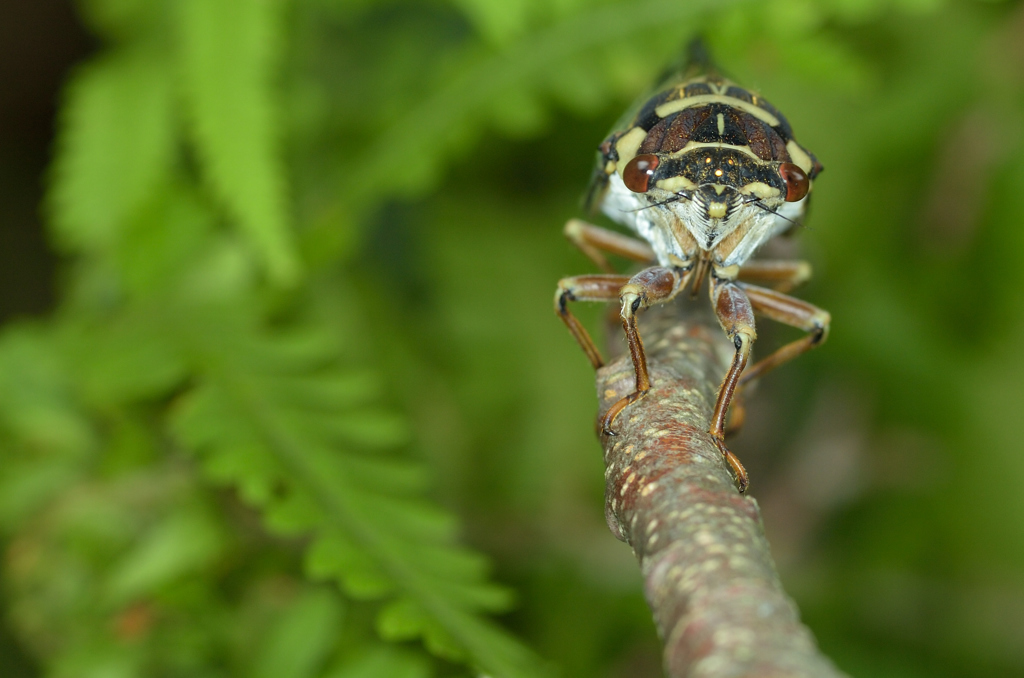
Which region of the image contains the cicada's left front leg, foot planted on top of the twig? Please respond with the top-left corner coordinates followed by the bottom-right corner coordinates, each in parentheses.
top-left (601, 266), bottom-right (693, 435)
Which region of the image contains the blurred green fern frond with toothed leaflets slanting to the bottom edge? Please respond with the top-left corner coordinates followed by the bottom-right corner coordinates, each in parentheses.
top-left (168, 311), bottom-right (543, 677)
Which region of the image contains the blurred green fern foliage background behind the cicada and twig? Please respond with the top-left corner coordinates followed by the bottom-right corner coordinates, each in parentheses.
top-left (0, 0), bottom-right (1024, 678)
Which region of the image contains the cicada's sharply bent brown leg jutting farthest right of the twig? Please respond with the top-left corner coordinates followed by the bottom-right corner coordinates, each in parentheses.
top-left (739, 283), bottom-right (831, 384)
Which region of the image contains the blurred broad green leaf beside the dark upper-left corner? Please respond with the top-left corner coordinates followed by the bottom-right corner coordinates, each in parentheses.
top-left (48, 49), bottom-right (175, 251)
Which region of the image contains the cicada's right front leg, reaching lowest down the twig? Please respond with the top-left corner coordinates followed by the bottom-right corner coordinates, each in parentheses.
top-left (709, 276), bottom-right (758, 492)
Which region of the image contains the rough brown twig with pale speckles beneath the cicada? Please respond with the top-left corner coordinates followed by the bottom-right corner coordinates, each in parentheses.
top-left (597, 304), bottom-right (844, 678)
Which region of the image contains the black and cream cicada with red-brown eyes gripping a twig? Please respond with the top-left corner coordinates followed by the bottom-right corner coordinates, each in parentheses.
top-left (555, 41), bottom-right (830, 492)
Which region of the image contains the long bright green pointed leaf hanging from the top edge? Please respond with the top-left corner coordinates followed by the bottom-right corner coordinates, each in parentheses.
top-left (178, 0), bottom-right (299, 283)
